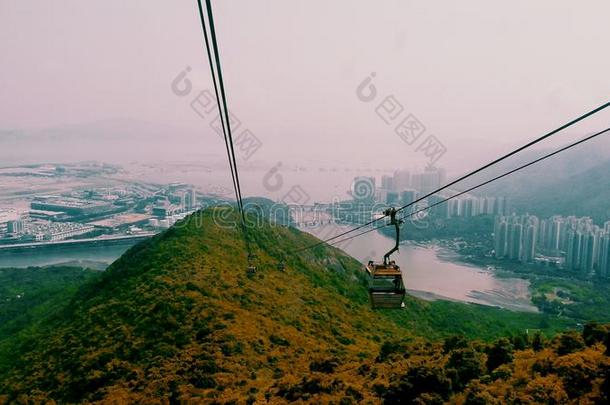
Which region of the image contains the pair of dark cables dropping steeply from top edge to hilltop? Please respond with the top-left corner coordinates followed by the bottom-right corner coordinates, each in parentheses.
top-left (197, 0), bottom-right (252, 260)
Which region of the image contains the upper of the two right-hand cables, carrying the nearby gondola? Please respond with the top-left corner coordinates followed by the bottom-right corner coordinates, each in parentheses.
top-left (292, 102), bottom-right (610, 253)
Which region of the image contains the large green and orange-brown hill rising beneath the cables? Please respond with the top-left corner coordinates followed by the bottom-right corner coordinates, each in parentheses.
top-left (0, 208), bottom-right (605, 403)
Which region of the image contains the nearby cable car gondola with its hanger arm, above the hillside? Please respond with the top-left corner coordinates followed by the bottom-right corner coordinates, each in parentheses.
top-left (365, 208), bottom-right (405, 309)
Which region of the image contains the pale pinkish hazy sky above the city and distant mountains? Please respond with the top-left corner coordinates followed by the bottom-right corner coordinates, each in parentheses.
top-left (0, 0), bottom-right (610, 170)
